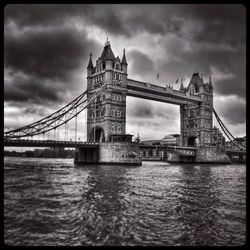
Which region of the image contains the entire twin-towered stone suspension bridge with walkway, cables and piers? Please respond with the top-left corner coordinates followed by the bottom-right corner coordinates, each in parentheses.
top-left (4, 41), bottom-right (246, 165)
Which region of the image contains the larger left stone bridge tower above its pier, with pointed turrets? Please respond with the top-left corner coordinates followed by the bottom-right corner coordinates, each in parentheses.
top-left (87, 41), bottom-right (128, 142)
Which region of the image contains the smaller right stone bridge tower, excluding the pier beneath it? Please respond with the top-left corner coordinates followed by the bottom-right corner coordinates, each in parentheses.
top-left (180, 73), bottom-right (213, 146)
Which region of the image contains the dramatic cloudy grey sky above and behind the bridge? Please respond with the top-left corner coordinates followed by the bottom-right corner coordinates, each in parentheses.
top-left (4, 4), bottom-right (246, 142)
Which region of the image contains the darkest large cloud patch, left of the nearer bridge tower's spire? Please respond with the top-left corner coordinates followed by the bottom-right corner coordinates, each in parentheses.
top-left (4, 24), bottom-right (94, 80)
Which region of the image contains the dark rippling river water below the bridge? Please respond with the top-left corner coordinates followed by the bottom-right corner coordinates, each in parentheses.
top-left (4, 157), bottom-right (246, 245)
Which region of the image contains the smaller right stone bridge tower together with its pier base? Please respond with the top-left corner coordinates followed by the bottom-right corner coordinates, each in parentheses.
top-left (180, 73), bottom-right (230, 163)
